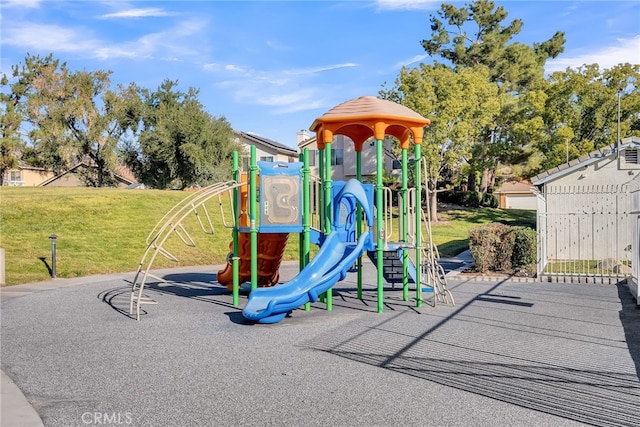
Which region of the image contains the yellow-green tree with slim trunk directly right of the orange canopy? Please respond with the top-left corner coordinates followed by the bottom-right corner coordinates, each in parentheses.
top-left (380, 64), bottom-right (502, 221)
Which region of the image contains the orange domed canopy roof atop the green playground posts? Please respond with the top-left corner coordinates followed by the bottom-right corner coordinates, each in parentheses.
top-left (309, 96), bottom-right (431, 151)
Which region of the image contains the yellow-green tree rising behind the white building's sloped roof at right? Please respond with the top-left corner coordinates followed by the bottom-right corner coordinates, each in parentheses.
top-left (537, 63), bottom-right (640, 170)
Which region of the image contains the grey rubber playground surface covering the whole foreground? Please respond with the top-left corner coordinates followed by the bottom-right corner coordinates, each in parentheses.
top-left (0, 263), bottom-right (640, 427)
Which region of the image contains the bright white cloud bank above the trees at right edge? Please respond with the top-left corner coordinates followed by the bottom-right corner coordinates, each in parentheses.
top-left (545, 34), bottom-right (640, 73)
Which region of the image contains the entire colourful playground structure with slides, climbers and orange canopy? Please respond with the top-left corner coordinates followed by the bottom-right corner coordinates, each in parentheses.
top-left (130, 96), bottom-right (454, 323)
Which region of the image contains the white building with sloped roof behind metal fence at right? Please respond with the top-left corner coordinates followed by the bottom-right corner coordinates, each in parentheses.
top-left (532, 137), bottom-right (640, 283)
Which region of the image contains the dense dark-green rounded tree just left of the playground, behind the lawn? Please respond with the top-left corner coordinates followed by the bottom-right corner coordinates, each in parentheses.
top-left (127, 80), bottom-right (239, 188)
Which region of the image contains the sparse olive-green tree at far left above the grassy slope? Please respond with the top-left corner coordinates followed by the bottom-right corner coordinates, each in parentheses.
top-left (5, 55), bottom-right (139, 187)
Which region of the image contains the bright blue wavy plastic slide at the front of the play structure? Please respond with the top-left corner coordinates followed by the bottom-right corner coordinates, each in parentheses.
top-left (242, 180), bottom-right (373, 323)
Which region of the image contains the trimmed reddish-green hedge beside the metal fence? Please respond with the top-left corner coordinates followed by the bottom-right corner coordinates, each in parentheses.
top-left (469, 223), bottom-right (537, 273)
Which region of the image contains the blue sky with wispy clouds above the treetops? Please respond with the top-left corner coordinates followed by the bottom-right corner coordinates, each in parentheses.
top-left (0, 0), bottom-right (640, 147)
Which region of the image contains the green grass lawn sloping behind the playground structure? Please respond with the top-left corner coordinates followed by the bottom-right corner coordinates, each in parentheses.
top-left (0, 187), bottom-right (535, 285)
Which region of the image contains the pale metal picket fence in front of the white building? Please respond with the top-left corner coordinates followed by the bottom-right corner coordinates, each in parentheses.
top-left (538, 184), bottom-right (633, 283)
